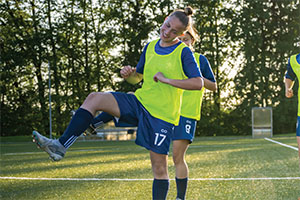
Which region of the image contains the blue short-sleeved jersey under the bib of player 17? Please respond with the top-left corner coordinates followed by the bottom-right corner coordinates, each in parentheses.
top-left (136, 40), bottom-right (202, 78)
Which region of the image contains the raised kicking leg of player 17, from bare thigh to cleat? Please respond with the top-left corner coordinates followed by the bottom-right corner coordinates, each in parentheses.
top-left (32, 92), bottom-right (120, 161)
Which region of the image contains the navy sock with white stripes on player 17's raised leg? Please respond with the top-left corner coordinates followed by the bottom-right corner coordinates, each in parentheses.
top-left (59, 108), bottom-right (94, 148)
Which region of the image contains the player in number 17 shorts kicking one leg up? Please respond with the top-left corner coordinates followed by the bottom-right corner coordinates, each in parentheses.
top-left (33, 7), bottom-right (203, 199)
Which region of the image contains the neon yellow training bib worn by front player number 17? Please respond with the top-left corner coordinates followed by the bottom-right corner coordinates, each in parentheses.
top-left (135, 40), bottom-right (186, 125)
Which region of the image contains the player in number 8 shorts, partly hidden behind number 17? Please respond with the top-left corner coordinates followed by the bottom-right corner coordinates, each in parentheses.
top-left (172, 27), bottom-right (217, 199)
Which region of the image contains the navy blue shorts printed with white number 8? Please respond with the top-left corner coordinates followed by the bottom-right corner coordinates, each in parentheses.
top-left (172, 116), bottom-right (197, 143)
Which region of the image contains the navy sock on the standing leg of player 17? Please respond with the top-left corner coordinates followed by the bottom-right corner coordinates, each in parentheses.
top-left (152, 179), bottom-right (169, 200)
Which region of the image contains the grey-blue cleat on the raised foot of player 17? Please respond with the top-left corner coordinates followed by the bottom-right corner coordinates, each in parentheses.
top-left (32, 131), bottom-right (67, 161)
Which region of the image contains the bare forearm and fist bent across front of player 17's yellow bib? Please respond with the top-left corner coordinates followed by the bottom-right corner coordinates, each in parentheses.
top-left (153, 72), bottom-right (204, 90)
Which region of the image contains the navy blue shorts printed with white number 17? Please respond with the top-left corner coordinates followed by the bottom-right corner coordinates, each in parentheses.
top-left (111, 92), bottom-right (174, 155)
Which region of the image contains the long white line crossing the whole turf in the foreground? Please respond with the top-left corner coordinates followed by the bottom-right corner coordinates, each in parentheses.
top-left (0, 177), bottom-right (300, 181)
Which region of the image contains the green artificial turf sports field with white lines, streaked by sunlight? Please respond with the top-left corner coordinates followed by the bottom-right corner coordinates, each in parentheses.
top-left (0, 134), bottom-right (300, 200)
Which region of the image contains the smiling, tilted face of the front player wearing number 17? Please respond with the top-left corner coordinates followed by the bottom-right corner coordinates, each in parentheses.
top-left (160, 16), bottom-right (185, 43)
